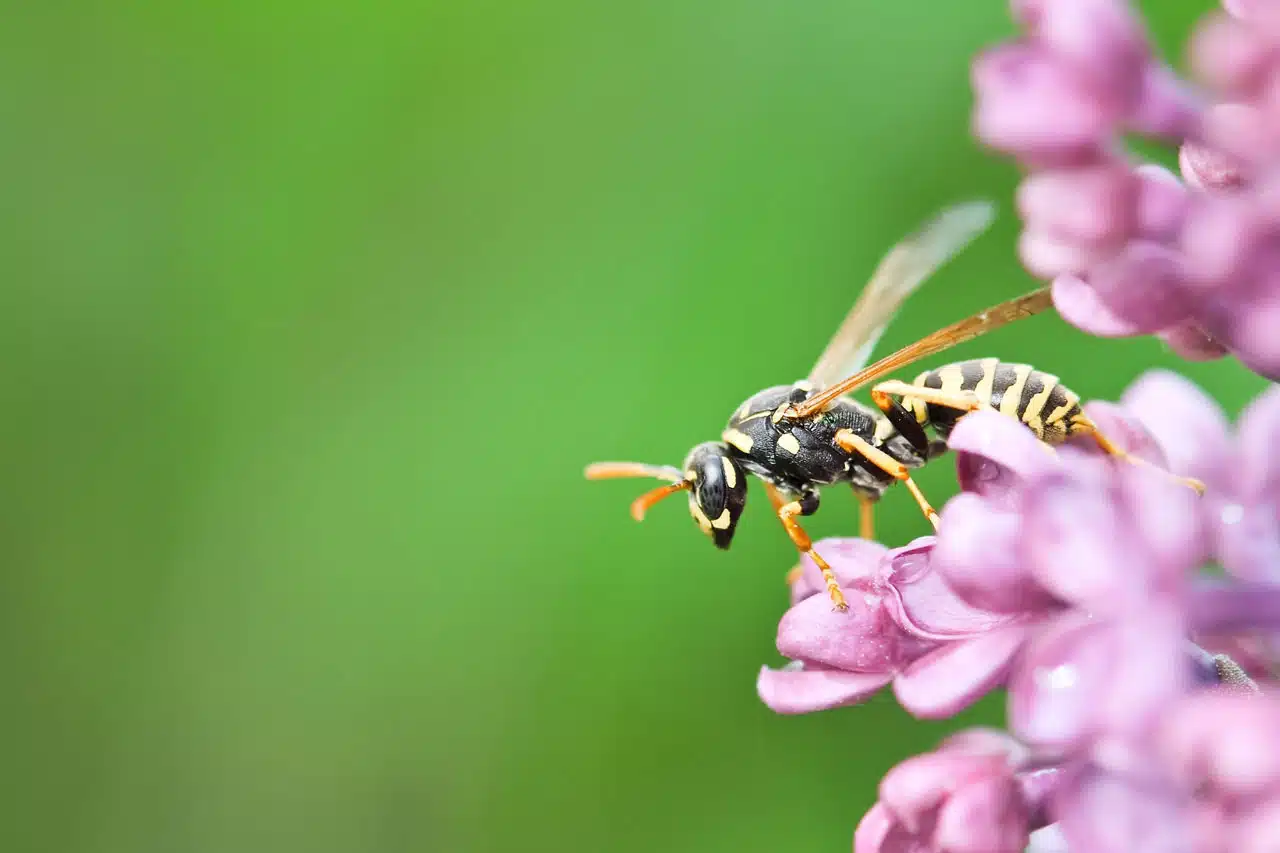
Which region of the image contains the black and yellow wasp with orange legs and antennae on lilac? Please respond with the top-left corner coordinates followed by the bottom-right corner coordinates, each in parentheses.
top-left (586, 201), bottom-right (1199, 610)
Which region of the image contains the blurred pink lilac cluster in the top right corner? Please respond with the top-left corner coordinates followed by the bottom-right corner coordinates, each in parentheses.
top-left (973, 0), bottom-right (1280, 379)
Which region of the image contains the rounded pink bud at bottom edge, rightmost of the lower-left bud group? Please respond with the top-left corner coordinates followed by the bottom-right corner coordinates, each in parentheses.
top-left (933, 776), bottom-right (1030, 853)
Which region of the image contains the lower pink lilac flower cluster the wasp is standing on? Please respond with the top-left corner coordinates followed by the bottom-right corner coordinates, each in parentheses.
top-left (758, 373), bottom-right (1280, 853)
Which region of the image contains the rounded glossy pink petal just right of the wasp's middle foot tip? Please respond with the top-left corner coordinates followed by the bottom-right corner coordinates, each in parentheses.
top-left (931, 492), bottom-right (1052, 613)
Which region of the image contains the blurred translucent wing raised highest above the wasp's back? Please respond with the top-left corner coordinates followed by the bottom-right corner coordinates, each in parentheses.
top-left (809, 200), bottom-right (996, 388)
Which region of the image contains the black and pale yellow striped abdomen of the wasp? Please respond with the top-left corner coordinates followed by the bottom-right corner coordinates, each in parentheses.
top-left (902, 359), bottom-right (1080, 444)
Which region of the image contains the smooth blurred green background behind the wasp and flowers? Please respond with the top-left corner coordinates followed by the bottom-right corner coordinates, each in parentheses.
top-left (0, 0), bottom-right (1262, 853)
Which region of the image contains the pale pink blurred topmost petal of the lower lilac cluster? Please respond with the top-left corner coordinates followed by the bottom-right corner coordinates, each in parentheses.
top-left (1120, 370), bottom-right (1231, 479)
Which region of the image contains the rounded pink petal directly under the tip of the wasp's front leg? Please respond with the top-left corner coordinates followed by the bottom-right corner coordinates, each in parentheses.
top-left (778, 589), bottom-right (929, 674)
